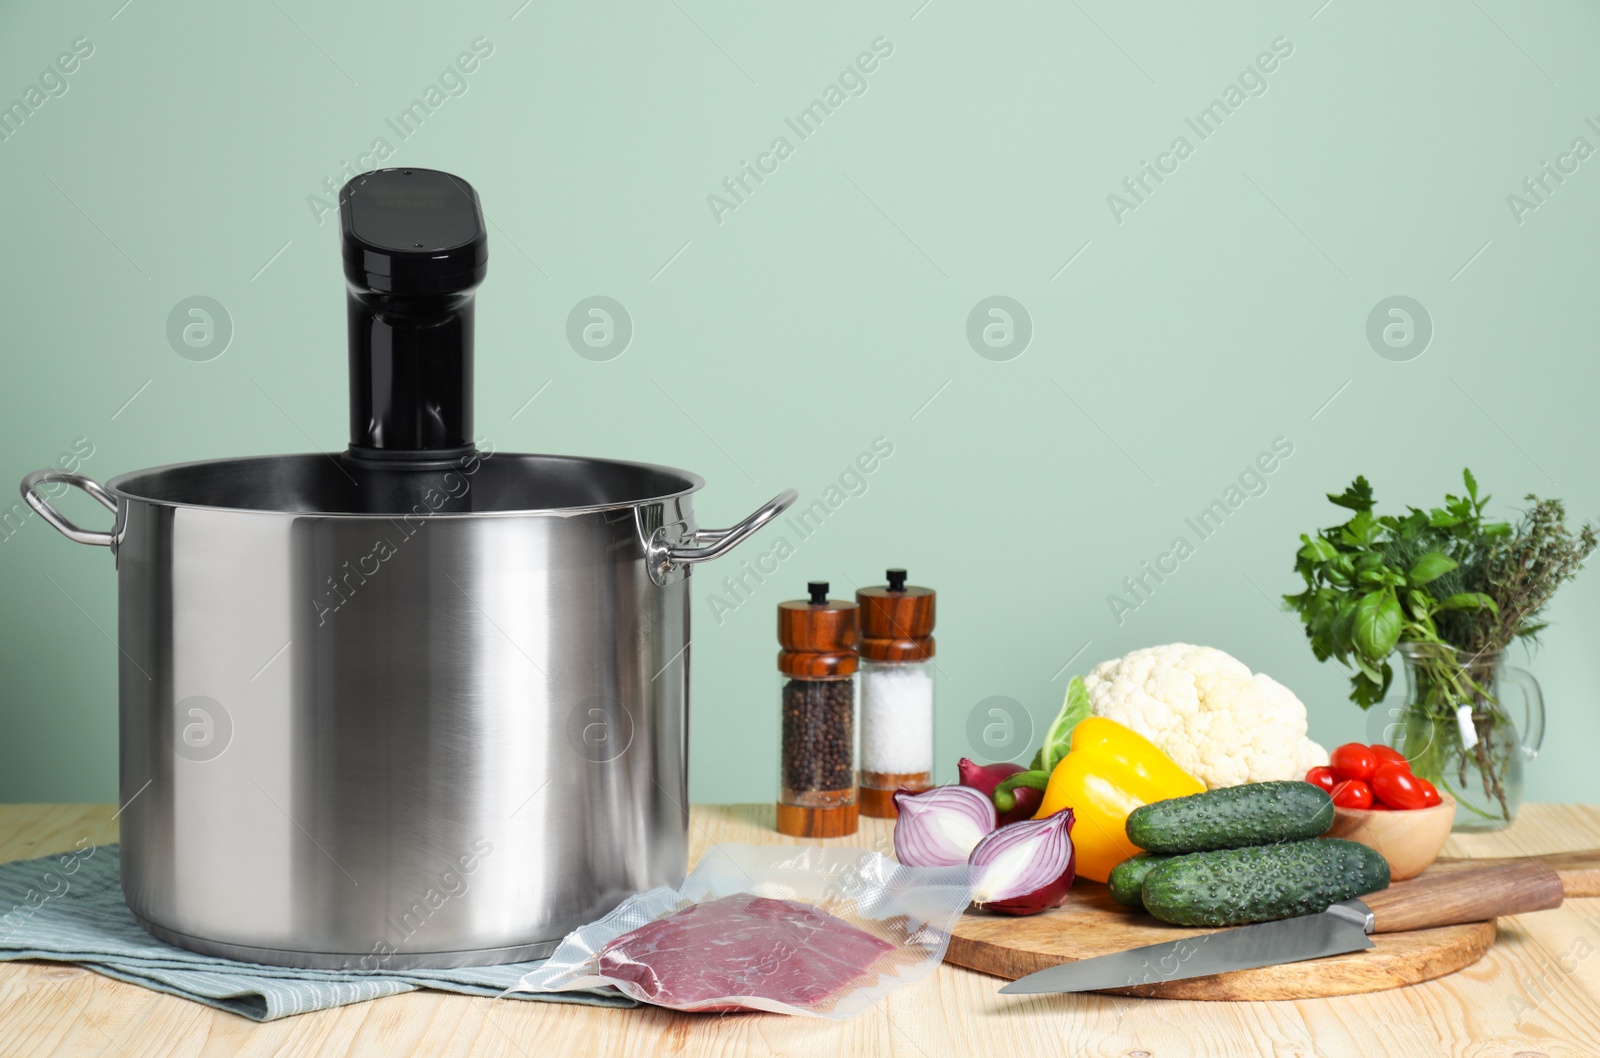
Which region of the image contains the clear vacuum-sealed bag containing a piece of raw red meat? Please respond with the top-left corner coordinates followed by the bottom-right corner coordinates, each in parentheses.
top-left (510, 845), bottom-right (971, 1020)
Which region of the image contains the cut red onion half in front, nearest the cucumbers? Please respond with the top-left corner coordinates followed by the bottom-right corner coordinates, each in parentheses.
top-left (968, 808), bottom-right (1077, 916)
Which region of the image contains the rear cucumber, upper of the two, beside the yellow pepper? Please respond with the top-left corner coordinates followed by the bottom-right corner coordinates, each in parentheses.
top-left (1128, 781), bottom-right (1333, 855)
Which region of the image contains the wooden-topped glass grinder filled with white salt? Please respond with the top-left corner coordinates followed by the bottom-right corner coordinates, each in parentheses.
top-left (856, 570), bottom-right (934, 820)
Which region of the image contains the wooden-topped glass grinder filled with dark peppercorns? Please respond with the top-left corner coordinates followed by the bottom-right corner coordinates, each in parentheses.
top-left (778, 581), bottom-right (861, 837)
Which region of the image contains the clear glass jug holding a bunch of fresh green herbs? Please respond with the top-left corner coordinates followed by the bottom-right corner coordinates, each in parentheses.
top-left (1285, 471), bottom-right (1597, 831)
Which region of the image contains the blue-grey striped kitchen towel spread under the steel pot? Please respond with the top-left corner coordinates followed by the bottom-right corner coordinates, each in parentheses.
top-left (0, 845), bottom-right (637, 1021)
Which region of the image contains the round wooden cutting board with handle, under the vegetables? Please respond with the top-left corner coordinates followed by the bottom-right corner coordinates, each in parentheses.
top-left (944, 852), bottom-right (1600, 1000)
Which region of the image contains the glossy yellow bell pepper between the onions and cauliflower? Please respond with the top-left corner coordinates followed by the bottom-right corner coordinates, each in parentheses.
top-left (1034, 717), bottom-right (1205, 882)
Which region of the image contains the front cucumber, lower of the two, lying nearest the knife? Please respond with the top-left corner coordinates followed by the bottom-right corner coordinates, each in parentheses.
top-left (1139, 837), bottom-right (1389, 927)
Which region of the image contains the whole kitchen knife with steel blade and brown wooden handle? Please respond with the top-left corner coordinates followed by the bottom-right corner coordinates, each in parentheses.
top-left (1000, 863), bottom-right (1562, 994)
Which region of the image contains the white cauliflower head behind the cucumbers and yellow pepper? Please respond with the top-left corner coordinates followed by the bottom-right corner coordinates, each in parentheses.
top-left (1083, 643), bottom-right (1328, 789)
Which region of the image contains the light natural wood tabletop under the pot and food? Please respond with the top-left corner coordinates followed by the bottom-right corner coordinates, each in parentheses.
top-left (0, 805), bottom-right (1600, 1058)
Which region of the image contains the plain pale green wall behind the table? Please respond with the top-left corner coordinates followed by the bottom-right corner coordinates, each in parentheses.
top-left (0, 0), bottom-right (1600, 800)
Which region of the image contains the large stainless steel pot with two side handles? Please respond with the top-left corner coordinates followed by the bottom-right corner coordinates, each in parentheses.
top-left (22, 170), bottom-right (795, 970)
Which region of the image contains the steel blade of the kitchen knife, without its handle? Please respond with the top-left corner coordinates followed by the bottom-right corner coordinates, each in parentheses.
top-left (1000, 900), bottom-right (1374, 994)
